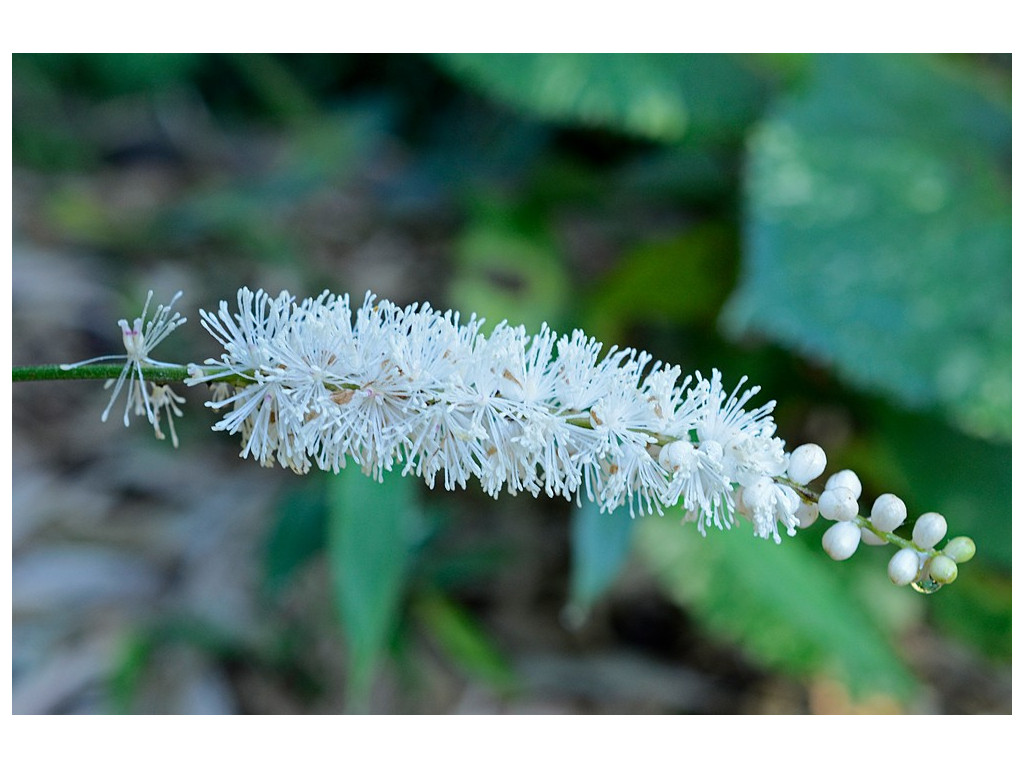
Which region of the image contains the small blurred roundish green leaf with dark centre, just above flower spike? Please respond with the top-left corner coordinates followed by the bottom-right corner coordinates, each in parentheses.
top-left (450, 219), bottom-right (569, 333)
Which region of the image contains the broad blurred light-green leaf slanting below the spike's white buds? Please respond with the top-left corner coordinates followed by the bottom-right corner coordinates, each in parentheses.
top-left (637, 518), bottom-right (914, 698)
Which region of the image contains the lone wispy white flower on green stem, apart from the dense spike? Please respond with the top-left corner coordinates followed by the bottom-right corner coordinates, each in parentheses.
top-left (60, 291), bottom-right (185, 430)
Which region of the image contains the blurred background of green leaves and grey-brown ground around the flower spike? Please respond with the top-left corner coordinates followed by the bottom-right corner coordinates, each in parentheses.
top-left (12, 54), bottom-right (1011, 714)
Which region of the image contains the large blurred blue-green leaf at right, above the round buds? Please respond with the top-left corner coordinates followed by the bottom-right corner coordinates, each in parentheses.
top-left (726, 55), bottom-right (1011, 437)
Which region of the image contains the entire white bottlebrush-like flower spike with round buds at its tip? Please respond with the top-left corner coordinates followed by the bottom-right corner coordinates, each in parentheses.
top-left (65, 288), bottom-right (974, 591)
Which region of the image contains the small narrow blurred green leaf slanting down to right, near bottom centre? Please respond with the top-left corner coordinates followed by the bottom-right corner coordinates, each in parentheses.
top-left (415, 593), bottom-right (515, 692)
